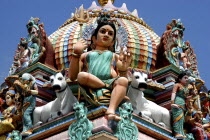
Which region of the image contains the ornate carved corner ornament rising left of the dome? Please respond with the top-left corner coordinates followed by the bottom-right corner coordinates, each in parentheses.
top-left (9, 17), bottom-right (56, 75)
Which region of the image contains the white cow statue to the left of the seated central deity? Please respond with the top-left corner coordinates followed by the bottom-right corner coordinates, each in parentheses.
top-left (33, 72), bottom-right (77, 127)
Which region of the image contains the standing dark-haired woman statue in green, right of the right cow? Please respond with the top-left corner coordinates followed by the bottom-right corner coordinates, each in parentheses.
top-left (171, 72), bottom-right (189, 138)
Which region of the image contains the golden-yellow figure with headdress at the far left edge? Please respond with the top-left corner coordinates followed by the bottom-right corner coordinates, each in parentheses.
top-left (0, 76), bottom-right (22, 139)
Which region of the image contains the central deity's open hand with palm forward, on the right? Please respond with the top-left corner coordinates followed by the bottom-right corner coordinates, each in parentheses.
top-left (117, 47), bottom-right (132, 71)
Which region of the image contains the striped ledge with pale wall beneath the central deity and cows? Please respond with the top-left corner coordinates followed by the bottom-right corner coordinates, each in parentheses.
top-left (25, 106), bottom-right (174, 140)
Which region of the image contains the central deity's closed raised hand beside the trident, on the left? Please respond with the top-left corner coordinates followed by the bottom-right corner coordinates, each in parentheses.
top-left (74, 39), bottom-right (87, 54)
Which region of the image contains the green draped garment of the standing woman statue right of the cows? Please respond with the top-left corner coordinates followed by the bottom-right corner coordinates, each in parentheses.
top-left (172, 88), bottom-right (189, 135)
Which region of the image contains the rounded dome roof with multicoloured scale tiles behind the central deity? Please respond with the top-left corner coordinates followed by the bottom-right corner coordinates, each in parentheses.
top-left (49, 1), bottom-right (160, 71)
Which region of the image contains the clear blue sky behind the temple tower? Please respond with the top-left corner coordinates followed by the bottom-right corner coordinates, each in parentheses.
top-left (0, 0), bottom-right (210, 89)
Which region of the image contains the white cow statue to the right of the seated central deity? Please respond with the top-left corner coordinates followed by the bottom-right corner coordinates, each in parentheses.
top-left (127, 70), bottom-right (171, 129)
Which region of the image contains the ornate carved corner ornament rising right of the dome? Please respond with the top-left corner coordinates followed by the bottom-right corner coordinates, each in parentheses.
top-left (156, 19), bottom-right (199, 78)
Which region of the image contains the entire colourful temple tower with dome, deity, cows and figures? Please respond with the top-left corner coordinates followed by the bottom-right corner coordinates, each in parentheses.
top-left (0, 0), bottom-right (210, 140)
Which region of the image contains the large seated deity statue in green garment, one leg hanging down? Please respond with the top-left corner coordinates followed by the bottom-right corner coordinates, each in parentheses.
top-left (69, 17), bottom-right (132, 120)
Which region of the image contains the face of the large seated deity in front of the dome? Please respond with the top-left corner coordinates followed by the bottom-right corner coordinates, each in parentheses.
top-left (93, 25), bottom-right (114, 48)
